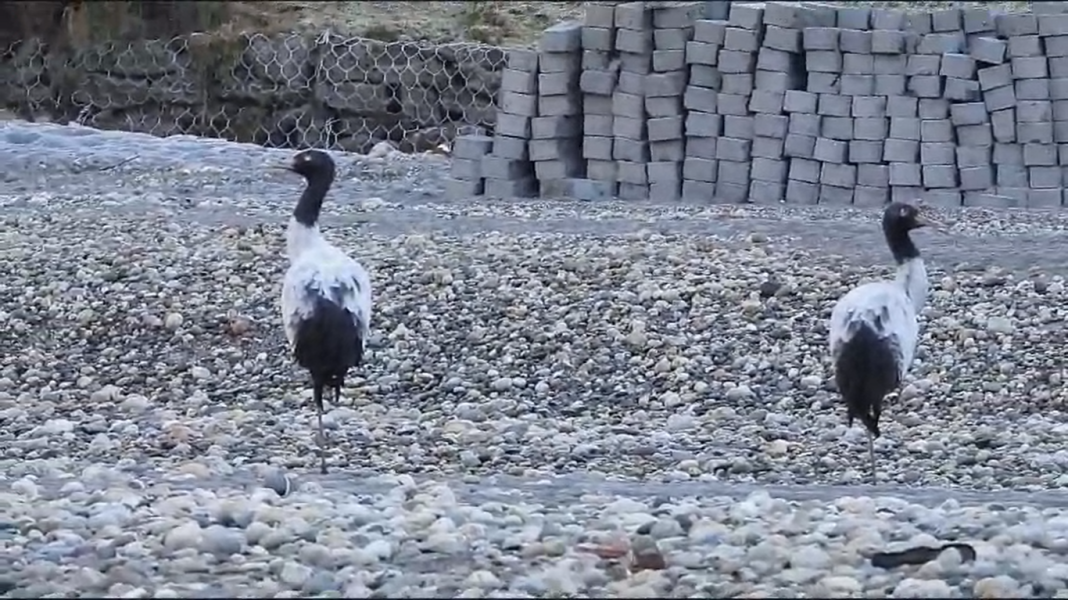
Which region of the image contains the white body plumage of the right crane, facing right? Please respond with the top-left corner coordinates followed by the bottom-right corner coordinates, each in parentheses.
top-left (830, 258), bottom-right (927, 379)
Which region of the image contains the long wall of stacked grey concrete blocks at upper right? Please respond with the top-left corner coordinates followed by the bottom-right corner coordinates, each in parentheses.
top-left (457, 2), bottom-right (1068, 207)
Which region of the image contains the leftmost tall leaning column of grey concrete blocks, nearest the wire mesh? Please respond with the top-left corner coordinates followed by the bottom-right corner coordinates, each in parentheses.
top-left (484, 49), bottom-right (538, 199)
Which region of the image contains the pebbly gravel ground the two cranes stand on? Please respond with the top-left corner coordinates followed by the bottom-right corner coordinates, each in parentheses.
top-left (0, 124), bottom-right (1068, 597)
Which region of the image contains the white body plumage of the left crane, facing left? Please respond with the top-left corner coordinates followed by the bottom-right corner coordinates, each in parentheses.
top-left (282, 221), bottom-right (372, 351)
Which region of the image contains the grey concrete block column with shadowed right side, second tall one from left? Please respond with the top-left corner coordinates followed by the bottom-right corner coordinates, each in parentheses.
top-left (530, 21), bottom-right (586, 198)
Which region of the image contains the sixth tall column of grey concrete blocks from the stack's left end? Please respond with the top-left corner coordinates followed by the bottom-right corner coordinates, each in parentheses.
top-left (682, 19), bottom-right (737, 202)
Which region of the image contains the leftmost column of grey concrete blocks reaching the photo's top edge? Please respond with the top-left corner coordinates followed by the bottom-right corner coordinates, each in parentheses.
top-left (579, 2), bottom-right (619, 196)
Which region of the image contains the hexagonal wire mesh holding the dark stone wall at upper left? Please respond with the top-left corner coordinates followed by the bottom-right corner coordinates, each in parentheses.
top-left (0, 33), bottom-right (505, 153)
